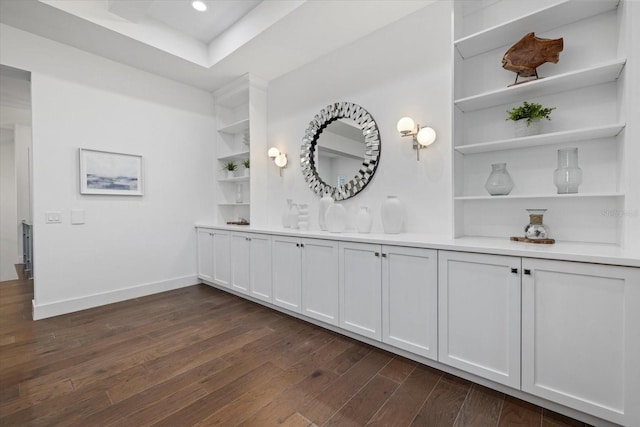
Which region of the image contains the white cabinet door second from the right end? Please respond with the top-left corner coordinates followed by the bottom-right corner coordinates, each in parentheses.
top-left (438, 251), bottom-right (521, 388)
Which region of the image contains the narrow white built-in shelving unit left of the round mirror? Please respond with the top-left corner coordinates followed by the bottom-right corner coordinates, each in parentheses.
top-left (213, 74), bottom-right (266, 224)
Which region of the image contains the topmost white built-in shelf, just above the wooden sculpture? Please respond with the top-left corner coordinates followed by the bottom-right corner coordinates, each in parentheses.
top-left (454, 0), bottom-right (619, 59)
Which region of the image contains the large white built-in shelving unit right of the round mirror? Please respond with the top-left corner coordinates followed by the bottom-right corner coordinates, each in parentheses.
top-left (453, 0), bottom-right (628, 245)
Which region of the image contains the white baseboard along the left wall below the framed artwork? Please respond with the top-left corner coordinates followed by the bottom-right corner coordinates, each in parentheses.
top-left (33, 274), bottom-right (200, 320)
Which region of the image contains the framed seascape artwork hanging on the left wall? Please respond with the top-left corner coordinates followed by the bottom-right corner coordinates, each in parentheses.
top-left (80, 148), bottom-right (143, 196)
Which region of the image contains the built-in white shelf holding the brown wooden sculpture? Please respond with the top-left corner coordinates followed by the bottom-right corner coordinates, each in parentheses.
top-left (455, 59), bottom-right (626, 112)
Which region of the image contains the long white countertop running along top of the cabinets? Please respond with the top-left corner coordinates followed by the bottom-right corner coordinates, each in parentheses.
top-left (196, 224), bottom-right (640, 267)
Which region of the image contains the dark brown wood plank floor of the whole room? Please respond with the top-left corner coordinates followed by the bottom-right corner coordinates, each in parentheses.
top-left (0, 274), bottom-right (583, 427)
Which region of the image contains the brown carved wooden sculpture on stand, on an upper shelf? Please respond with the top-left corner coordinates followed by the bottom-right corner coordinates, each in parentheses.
top-left (502, 33), bottom-right (564, 86)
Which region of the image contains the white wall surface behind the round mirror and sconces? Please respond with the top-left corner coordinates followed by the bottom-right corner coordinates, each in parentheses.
top-left (264, 2), bottom-right (452, 236)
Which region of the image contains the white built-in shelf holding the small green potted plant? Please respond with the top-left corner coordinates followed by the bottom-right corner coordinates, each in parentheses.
top-left (455, 123), bottom-right (625, 154)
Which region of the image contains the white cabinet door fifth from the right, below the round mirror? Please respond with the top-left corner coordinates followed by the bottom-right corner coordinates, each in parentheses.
top-left (301, 239), bottom-right (339, 326)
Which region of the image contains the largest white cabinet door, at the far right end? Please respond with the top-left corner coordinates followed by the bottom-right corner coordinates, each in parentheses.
top-left (522, 259), bottom-right (640, 425)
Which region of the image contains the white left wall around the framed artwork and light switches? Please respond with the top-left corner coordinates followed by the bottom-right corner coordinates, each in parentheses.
top-left (0, 25), bottom-right (215, 318)
